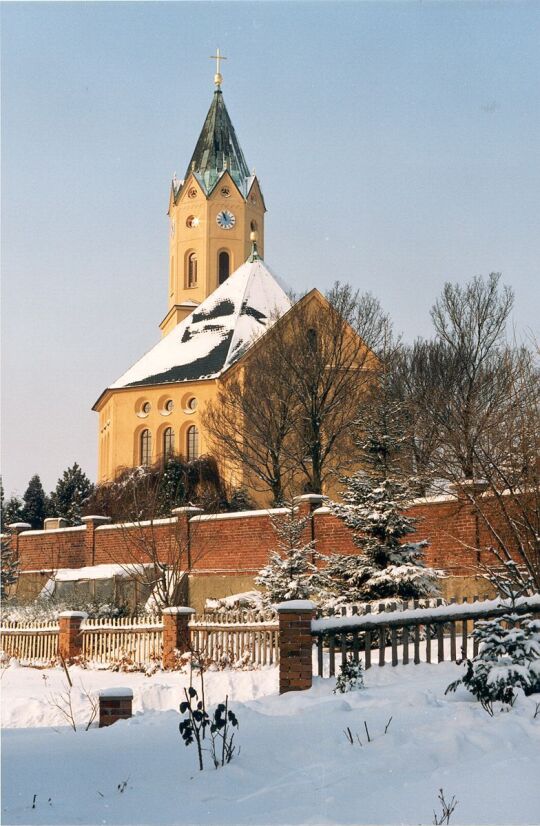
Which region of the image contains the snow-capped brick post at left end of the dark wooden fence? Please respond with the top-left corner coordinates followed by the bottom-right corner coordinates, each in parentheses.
top-left (276, 599), bottom-right (315, 694)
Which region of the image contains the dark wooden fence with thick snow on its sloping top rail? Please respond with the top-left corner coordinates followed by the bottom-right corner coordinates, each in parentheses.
top-left (311, 595), bottom-right (540, 677)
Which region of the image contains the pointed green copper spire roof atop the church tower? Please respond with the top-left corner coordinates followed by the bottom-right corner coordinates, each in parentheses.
top-left (185, 88), bottom-right (250, 193)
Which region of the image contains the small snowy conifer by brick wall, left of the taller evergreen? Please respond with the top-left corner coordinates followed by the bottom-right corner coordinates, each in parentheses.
top-left (255, 505), bottom-right (317, 605)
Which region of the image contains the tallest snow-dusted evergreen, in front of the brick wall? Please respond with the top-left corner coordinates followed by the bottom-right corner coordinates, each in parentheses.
top-left (319, 369), bottom-right (439, 603)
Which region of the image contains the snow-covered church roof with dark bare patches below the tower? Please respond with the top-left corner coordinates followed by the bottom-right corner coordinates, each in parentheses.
top-left (106, 259), bottom-right (291, 389)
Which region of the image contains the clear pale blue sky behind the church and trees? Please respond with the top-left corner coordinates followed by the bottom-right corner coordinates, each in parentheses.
top-left (1, 2), bottom-right (540, 494)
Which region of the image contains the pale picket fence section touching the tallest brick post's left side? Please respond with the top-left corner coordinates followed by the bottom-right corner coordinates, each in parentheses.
top-left (189, 610), bottom-right (279, 665)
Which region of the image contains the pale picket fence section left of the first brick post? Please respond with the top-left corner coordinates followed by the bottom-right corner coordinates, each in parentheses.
top-left (0, 620), bottom-right (58, 665)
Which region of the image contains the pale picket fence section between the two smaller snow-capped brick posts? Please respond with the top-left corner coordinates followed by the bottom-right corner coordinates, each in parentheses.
top-left (81, 616), bottom-right (163, 666)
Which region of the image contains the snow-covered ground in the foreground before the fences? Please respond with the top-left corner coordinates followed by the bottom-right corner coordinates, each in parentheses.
top-left (0, 663), bottom-right (540, 826)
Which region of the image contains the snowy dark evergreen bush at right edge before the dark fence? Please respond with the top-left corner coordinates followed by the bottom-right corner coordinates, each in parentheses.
top-left (446, 604), bottom-right (540, 715)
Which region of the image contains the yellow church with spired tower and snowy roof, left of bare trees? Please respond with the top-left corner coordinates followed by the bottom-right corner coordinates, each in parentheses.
top-left (93, 56), bottom-right (291, 490)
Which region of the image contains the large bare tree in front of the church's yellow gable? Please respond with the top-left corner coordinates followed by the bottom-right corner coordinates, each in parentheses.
top-left (205, 283), bottom-right (389, 502)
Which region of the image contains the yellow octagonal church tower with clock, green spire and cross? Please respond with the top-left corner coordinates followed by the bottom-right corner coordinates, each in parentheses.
top-left (159, 49), bottom-right (266, 335)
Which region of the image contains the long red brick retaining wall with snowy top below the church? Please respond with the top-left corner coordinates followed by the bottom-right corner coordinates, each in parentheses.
top-left (9, 492), bottom-right (516, 576)
